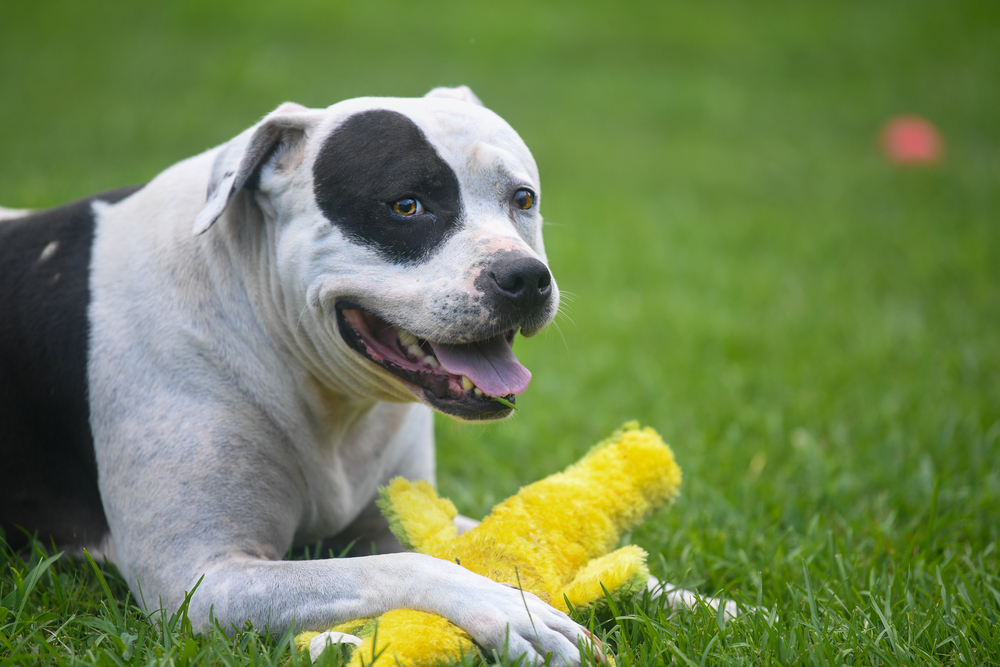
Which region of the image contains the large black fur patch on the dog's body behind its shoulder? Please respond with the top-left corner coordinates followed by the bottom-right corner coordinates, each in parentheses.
top-left (0, 186), bottom-right (141, 549)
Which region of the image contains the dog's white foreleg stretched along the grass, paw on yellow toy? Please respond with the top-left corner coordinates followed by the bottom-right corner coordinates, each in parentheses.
top-left (189, 553), bottom-right (590, 665)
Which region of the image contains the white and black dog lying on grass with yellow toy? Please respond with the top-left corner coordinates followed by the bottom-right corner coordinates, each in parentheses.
top-left (0, 87), bottom-right (736, 665)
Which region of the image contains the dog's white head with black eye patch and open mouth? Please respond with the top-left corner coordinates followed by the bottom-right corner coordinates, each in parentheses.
top-left (195, 87), bottom-right (559, 419)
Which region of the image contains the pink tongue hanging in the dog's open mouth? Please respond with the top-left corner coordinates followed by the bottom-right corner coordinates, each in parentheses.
top-left (431, 336), bottom-right (531, 396)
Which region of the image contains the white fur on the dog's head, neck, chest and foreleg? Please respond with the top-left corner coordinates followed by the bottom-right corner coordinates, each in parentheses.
top-left (88, 91), bottom-right (586, 664)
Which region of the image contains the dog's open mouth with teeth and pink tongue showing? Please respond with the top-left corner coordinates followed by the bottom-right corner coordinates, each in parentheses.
top-left (337, 304), bottom-right (531, 419)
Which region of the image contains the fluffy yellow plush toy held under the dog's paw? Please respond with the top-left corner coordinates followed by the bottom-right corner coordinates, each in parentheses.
top-left (295, 422), bottom-right (681, 667)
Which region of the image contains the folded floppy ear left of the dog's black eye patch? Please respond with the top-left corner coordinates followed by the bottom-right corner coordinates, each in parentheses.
top-left (193, 102), bottom-right (316, 235)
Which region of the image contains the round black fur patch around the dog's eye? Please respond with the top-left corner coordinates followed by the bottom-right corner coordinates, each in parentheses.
top-left (313, 109), bottom-right (462, 264)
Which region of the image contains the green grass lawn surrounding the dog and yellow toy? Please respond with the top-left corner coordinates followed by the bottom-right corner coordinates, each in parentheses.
top-left (0, 0), bottom-right (1000, 667)
